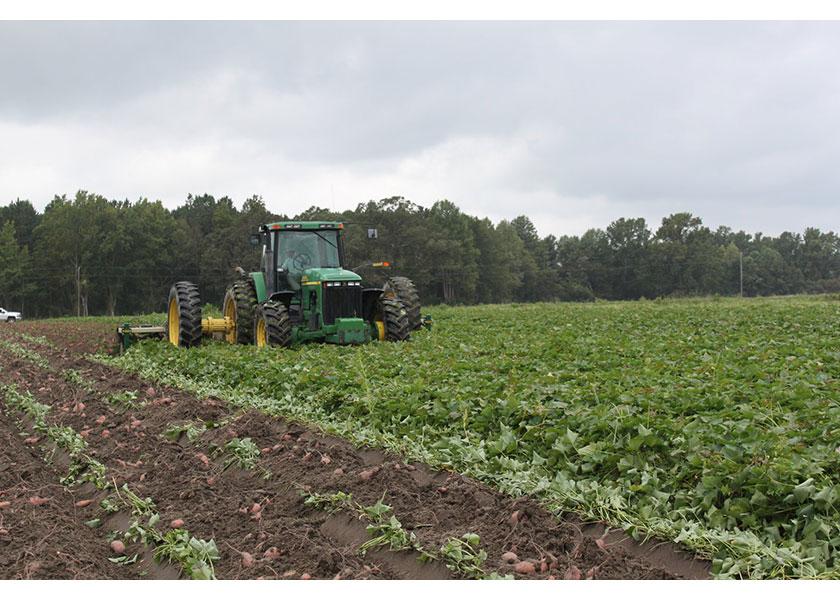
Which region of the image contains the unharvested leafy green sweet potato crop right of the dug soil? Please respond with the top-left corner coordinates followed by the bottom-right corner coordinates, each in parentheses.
top-left (101, 298), bottom-right (840, 577)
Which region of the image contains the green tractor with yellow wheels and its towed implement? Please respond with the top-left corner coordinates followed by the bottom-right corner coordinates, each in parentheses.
top-left (161, 221), bottom-right (430, 348)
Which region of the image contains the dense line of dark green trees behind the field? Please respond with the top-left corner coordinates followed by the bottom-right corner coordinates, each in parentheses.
top-left (0, 191), bottom-right (840, 317)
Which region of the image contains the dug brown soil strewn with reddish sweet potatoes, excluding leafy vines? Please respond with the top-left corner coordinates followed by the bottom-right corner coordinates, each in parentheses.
top-left (0, 321), bottom-right (709, 579)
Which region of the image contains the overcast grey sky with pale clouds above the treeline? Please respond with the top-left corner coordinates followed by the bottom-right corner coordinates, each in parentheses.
top-left (0, 22), bottom-right (840, 235)
